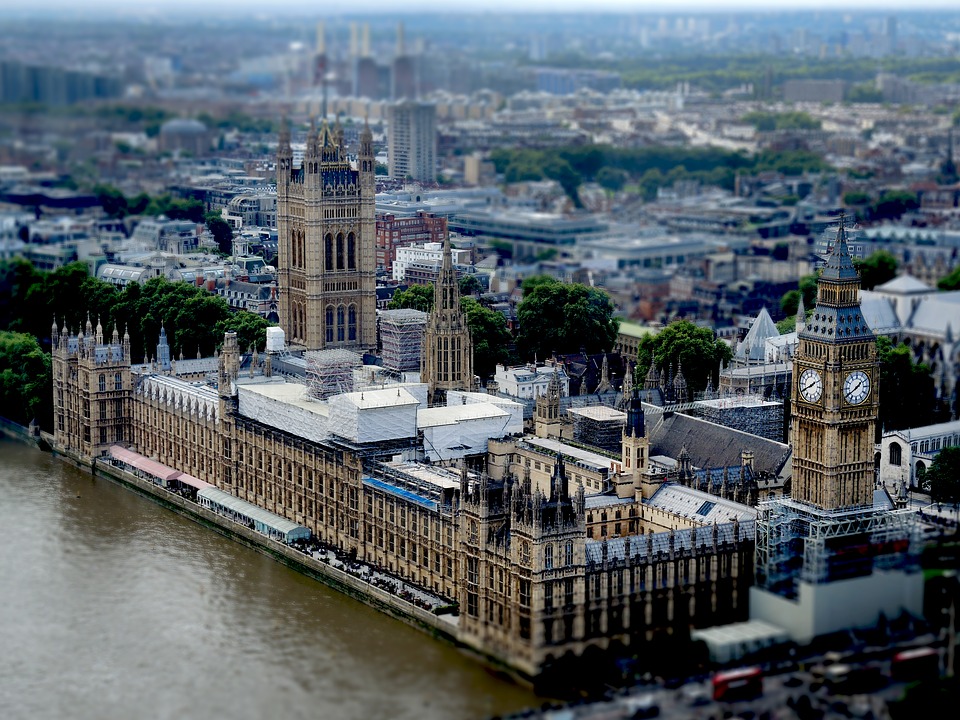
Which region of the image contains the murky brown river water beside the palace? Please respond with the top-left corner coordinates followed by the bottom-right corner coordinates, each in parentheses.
top-left (0, 436), bottom-right (542, 720)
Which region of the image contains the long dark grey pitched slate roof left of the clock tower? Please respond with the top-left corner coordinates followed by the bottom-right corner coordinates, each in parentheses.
top-left (647, 413), bottom-right (790, 475)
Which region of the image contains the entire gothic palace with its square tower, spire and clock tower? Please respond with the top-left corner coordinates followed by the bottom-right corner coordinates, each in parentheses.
top-left (52, 123), bottom-right (916, 676)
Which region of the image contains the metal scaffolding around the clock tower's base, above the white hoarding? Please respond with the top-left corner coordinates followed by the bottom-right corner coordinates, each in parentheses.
top-left (756, 498), bottom-right (920, 598)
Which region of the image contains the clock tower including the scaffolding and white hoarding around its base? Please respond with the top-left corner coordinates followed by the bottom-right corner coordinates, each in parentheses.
top-left (750, 218), bottom-right (923, 643)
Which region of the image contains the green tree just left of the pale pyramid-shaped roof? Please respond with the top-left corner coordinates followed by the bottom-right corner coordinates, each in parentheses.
top-left (637, 320), bottom-right (733, 400)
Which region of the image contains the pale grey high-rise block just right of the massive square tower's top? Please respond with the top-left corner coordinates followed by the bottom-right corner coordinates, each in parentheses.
top-left (387, 101), bottom-right (437, 183)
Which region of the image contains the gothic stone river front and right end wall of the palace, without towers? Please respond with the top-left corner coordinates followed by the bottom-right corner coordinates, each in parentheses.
top-left (54, 333), bottom-right (753, 676)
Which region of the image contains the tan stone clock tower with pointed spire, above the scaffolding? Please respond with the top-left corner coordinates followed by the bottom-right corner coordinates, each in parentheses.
top-left (791, 218), bottom-right (877, 510)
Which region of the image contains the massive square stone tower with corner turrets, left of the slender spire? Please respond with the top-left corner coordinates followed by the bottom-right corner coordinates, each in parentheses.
top-left (277, 117), bottom-right (377, 353)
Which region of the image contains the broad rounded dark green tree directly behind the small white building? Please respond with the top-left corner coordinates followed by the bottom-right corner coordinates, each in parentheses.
top-left (517, 276), bottom-right (620, 358)
